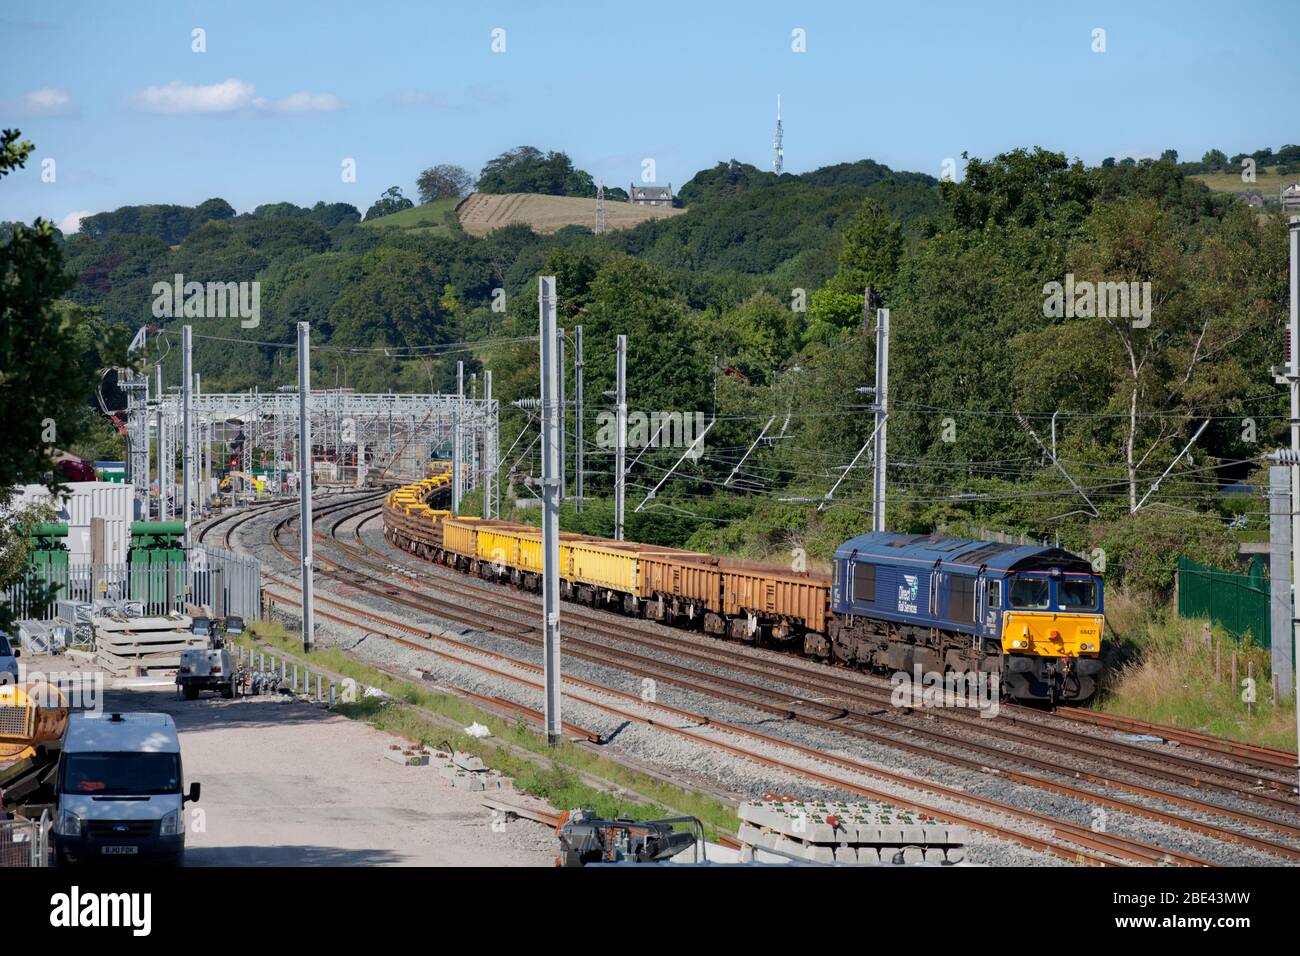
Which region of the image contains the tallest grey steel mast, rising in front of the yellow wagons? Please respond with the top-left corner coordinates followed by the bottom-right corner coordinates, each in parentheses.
top-left (537, 276), bottom-right (562, 745)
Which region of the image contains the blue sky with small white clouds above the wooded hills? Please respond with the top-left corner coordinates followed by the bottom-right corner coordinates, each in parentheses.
top-left (0, 0), bottom-right (1300, 230)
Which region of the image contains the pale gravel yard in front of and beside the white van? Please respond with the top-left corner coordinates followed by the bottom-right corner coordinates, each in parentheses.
top-left (94, 687), bottom-right (556, 866)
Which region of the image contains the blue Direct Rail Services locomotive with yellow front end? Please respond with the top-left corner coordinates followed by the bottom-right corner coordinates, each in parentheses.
top-left (807, 532), bottom-right (1104, 704)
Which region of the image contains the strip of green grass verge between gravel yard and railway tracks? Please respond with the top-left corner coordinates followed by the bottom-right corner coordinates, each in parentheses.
top-left (236, 622), bottom-right (740, 839)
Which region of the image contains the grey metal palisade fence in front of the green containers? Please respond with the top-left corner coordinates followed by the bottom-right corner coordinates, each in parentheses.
top-left (0, 545), bottom-right (261, 620)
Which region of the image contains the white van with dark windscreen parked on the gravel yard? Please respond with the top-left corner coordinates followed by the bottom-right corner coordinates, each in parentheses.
top-left (53, 713), bottom-right (199, 864)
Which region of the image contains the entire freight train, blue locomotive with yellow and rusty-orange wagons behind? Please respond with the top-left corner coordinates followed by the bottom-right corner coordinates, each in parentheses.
top-left (384, 462), bottom-right (1104, 704)
